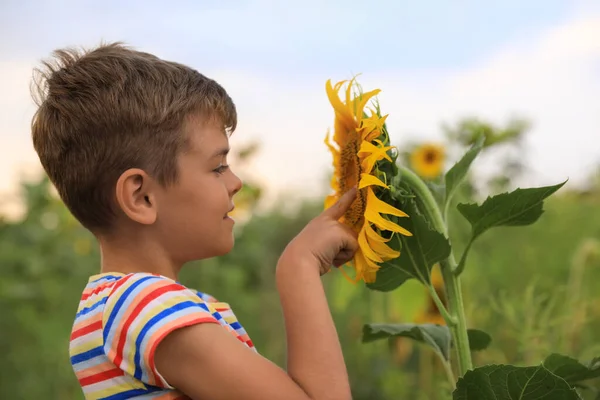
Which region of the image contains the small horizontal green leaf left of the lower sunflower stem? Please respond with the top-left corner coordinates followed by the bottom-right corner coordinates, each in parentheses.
top-left (362, 324), bottom-right (452, 360)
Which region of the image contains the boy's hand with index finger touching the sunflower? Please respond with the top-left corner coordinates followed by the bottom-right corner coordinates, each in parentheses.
top-left (281, 188), bottom-right (358, 275)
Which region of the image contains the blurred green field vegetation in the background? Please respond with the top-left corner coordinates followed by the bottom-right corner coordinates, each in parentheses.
top-left (0, 120), bottom-right (600, 400)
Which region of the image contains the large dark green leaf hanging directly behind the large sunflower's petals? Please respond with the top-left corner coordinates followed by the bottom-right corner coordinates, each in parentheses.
top-left (367, 200), bottom-right (451, 292)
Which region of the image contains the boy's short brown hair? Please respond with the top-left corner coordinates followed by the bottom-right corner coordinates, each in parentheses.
top-left (32, 43), bottom-right (237, 232)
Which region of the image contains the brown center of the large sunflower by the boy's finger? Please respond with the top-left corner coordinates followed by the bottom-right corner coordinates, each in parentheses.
top-left (339, 131), bottom-right (367, 227)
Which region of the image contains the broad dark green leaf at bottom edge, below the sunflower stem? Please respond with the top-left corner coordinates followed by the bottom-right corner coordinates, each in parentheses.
top-left (452, 365), bottom-right (581, 400)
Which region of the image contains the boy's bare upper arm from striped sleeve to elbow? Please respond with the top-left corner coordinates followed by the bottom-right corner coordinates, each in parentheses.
top-left (154, 318), bottom-right (322, 400)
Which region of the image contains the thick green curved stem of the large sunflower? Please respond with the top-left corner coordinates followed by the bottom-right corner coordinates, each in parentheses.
top-left (399, 166), bottom-right (473, 377)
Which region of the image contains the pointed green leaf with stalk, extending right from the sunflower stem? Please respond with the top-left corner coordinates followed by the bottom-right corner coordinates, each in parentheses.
top-left (456, 181), bottom-right (566, 274)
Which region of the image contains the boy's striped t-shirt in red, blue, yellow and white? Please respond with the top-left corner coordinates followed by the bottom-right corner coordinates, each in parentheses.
top-left (69, 273), bottom-right (256, 400)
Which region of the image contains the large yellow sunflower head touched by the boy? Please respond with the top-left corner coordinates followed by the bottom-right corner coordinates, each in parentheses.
top-left (325, 79), bottom-right (411, 283)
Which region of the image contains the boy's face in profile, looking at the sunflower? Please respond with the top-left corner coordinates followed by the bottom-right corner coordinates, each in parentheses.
top-left (156, 117), bottom-right (242, 263)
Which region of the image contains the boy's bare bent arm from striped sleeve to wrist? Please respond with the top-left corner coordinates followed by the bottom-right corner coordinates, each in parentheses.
top-left (154, 263), bottom-right (351, 400)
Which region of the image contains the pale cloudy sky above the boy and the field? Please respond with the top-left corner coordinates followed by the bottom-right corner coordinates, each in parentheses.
top-left (0, 0), bottom-right (600, 217)
